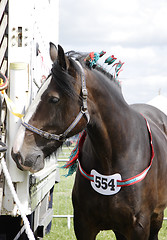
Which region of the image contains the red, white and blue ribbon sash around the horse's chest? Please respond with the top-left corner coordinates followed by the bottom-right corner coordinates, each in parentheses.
top-left (64, 118), bottom-right (154, 187)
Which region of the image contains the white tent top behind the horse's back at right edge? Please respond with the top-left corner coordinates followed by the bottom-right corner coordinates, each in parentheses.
top-left (147, 95), bottom-right (167, 115)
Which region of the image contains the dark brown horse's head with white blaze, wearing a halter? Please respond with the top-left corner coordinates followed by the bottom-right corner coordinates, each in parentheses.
top-left (12, 43), bottom-right (88, 172)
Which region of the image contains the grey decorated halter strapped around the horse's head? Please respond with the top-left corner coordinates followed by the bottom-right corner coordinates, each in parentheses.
top-left (21, 61), bottom-right (90, 141)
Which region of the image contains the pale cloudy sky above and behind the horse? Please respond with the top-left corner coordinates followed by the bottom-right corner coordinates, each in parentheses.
top-left (59, 0), bottom-right (167, 104)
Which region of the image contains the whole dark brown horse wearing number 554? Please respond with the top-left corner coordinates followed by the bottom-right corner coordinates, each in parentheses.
top-left (11, 43), bottom-right (167, 240)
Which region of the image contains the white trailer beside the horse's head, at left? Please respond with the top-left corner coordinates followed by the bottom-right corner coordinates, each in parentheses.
top-left (0, 0), bottom-right (59, 240)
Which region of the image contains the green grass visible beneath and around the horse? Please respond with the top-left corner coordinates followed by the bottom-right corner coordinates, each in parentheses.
top-left (44, 145), bottom-right (167, 240)
